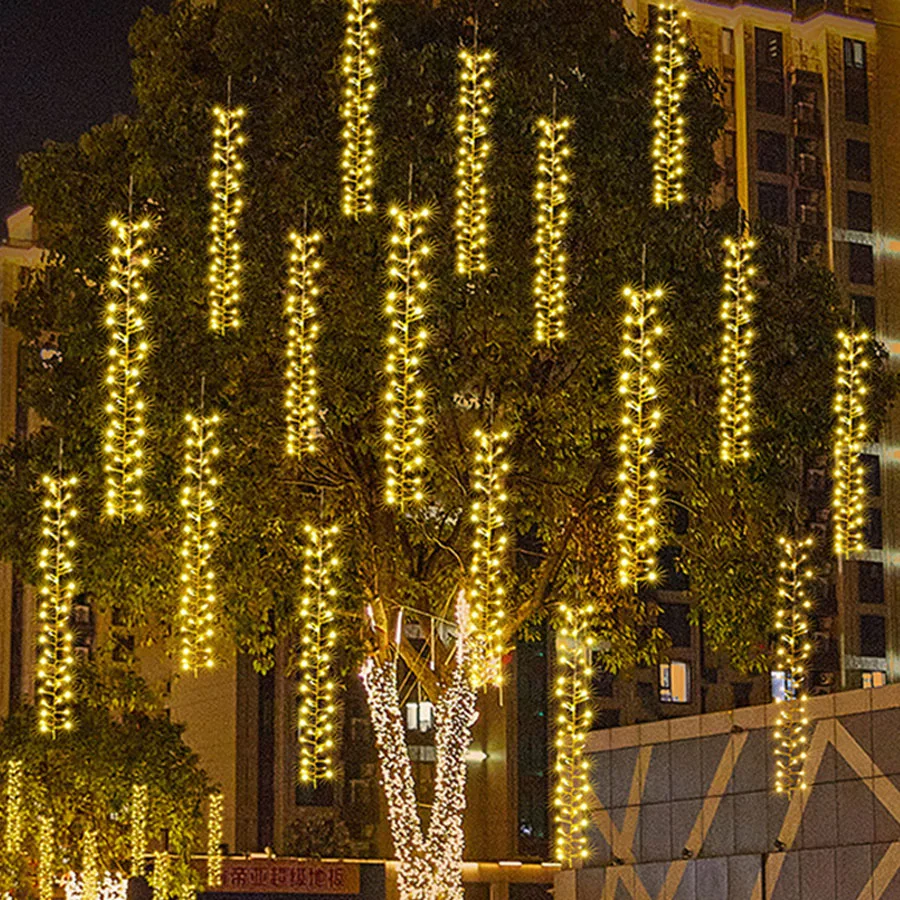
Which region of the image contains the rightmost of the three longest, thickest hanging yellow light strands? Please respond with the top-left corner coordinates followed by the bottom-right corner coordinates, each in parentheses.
top-left (616, 288), bottom-right (663, 590)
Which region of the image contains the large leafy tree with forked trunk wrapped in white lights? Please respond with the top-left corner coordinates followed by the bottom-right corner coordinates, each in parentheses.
top-left (0, 0), bottom-right (884, 897)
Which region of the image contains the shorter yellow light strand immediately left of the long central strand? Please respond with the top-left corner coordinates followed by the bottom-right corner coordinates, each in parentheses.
top-left (284, 232), bottom-right (322, 456)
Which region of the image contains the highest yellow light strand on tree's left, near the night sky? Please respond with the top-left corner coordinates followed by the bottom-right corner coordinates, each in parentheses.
top-left (209, 106), bottom-right (246, 334)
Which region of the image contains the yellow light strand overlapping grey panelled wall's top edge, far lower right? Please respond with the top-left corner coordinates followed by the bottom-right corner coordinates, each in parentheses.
top-left (775, 537), bottom-right (813, 795)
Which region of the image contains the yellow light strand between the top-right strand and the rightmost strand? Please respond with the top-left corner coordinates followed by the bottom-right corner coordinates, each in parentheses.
top-left (719, 236), bottom-right (756, 463)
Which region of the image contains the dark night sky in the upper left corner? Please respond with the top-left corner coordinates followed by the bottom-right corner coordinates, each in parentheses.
top-left (0, 0), bottom-right (168, 237)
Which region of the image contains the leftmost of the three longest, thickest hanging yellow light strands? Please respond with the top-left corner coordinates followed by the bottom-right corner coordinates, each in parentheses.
top-left (103, 219), bottom-right (150, 521)
